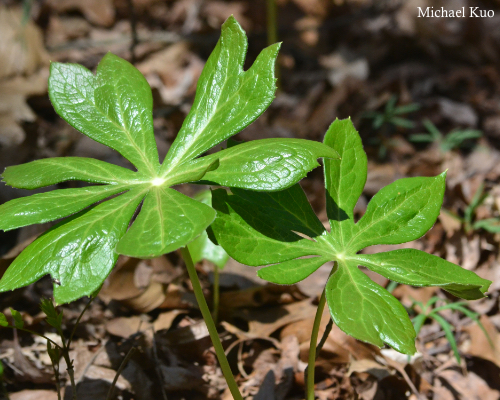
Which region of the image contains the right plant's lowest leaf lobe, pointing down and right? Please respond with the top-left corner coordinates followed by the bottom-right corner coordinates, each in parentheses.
top-left (325, 262), bottom-right (416, 354)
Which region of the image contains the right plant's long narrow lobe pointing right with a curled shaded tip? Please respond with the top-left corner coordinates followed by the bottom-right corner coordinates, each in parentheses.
top-left (352, 249), bottom-right (491, 300)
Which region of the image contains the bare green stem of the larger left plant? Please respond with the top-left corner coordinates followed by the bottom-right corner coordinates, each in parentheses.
top-left (181, 247), bottom-right (243, 400)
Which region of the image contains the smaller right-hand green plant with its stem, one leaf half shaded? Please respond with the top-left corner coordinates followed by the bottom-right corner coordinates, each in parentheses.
top-left (211, 119), bottom-right (491, 399)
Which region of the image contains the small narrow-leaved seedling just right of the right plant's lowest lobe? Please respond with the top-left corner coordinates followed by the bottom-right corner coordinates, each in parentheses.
top-left (411, 296), bottom-right (495, 364)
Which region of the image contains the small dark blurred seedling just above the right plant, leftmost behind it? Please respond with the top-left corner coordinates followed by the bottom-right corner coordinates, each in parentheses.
top-left (362, 95), bottom-right (420, 130)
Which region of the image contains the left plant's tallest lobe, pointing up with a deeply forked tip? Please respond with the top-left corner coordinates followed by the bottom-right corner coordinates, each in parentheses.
top-left (161, 16), bottom-right (280, 172)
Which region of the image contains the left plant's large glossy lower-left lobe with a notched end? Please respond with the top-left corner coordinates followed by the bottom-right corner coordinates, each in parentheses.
top-left (0, 190), bottom-right (144, 303)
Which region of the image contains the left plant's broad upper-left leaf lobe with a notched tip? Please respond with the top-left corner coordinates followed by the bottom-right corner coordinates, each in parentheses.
top-left (49, 53), bottom-right (160, 175)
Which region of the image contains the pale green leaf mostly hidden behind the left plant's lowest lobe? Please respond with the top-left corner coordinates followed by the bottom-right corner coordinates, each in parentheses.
top-left (188, 190), bottom-right (229, 269)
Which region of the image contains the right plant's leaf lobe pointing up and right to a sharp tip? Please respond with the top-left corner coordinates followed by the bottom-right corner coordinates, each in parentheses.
top-left (349, 173), bottom-right (446, 252)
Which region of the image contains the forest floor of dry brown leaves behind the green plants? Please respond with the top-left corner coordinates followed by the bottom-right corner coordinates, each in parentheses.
top-left (0, 0), bottom-right (500, 400)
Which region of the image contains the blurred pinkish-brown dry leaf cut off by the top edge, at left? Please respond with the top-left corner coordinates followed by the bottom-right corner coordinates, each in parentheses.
top-left (48, 0), bottom-right (115, 26)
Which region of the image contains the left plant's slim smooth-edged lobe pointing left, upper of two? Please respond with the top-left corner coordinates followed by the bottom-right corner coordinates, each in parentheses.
top-left (2, 157), bottom-right (141, 189)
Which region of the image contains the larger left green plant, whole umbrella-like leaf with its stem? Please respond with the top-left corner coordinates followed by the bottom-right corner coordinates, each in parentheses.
top-left (0, 17), bottom-right (338, 399)
